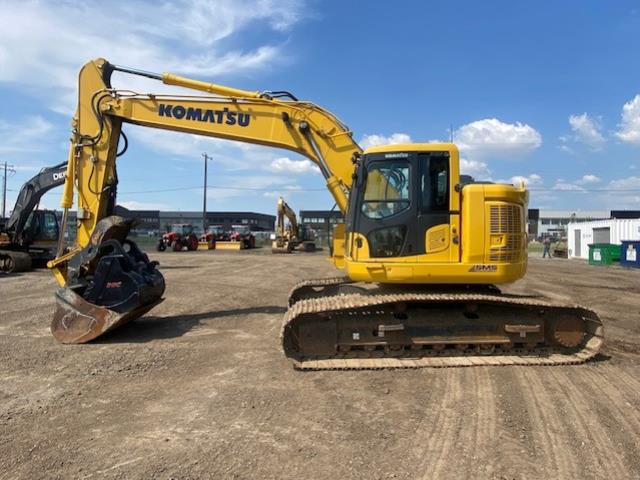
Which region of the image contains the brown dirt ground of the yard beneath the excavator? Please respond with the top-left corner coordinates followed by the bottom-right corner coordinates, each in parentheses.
top-left (0, 249), bottom-right (640, 480)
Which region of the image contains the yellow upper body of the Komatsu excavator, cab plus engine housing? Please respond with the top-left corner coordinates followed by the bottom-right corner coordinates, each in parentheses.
top-left (344, 143), bottom-right (528, 285)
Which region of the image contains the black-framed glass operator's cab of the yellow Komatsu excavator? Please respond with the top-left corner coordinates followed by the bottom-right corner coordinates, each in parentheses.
top-left (346, 150), bottom-right (448, 260)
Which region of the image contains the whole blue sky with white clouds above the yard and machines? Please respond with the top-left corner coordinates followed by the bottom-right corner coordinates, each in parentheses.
top-left (0, 0), bottom-right (640, 213)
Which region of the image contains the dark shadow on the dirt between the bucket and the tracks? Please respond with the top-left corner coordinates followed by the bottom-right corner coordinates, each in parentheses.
top-left (93, 305), bottom-right (287, 343)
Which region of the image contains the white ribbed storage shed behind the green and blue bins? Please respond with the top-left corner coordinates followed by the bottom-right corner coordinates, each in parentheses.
top-left (567, 218), bottom-right (640, 258)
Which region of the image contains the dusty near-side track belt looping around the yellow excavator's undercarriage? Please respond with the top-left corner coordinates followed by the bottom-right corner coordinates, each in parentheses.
top-left (281, 288), bottom-right (604, 370)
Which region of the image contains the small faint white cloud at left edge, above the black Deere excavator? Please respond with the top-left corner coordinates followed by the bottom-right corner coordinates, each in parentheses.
top-left (0, 115), bottom-right (57, 155)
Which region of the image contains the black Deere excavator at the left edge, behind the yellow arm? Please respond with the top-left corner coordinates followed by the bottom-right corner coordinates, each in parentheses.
top-left (0, 162), bottom-right (67, 273)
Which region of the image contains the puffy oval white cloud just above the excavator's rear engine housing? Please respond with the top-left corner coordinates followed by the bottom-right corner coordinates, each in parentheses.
top-left (454, 118), bottom-right (542, 159)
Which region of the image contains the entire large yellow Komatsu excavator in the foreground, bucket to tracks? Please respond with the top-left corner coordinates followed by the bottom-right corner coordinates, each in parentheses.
top-left (49, 59), bottom-right (603, 369)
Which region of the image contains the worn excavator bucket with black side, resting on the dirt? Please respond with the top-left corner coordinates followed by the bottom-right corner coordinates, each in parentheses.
top-left (51, 216), bottom-right (165, 343)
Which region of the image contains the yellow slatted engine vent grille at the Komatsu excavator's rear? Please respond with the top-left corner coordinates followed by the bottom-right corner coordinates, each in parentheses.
top-left (489, 205), bottom-right (525, 262)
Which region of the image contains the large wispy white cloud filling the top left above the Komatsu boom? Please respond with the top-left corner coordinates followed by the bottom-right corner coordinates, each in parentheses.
top-left (0, 0), bottom-right (305, 113)
